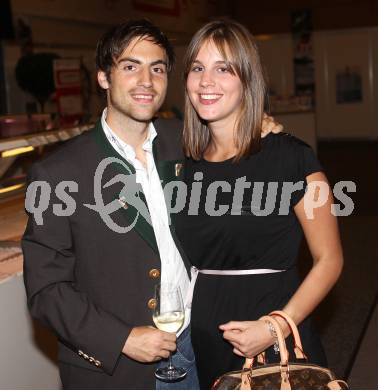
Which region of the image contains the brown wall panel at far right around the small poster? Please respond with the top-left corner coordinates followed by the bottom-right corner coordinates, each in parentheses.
top-left (314, 28), bottom-right (378, 139)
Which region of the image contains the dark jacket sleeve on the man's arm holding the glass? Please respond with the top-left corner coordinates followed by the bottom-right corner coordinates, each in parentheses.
top-left (22, 164), bottom-right (132, 374)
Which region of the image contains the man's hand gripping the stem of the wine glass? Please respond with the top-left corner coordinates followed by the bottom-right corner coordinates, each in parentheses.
top-left (122, 326), bottom-right (176, 363)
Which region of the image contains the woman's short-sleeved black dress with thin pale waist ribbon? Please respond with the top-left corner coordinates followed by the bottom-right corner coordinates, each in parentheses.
top-left (175, 133), bottom-right (326, 390)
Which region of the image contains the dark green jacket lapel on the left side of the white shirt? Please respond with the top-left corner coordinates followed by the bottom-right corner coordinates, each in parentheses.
top-left (94, 122), bottom-right (159, 253)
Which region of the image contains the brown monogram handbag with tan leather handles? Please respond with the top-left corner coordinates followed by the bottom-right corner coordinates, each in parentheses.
top-left (212, 311), bottom-right (349, 390)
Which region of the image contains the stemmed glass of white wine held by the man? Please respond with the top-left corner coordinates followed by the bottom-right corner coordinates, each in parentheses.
top-left (152, 283), bottom-right (186, 382)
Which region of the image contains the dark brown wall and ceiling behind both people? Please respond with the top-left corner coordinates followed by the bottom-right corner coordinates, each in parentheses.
top-left (4, 0), bottom-right (378, 138)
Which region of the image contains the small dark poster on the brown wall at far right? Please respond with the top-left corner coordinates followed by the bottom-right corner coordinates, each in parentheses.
top-left (336, 66), bottom-right (362, 104)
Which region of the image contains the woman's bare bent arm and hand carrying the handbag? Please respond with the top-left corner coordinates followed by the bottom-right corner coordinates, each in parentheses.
top-left (220, 172), bottom-right (343, 357)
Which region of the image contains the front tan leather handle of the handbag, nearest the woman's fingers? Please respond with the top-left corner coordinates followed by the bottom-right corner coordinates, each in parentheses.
top-left (240, 316), bottom-right (291, 390)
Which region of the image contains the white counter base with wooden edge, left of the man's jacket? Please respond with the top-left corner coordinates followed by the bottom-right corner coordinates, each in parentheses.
top-left (0, 242), bottom-right (61, 390)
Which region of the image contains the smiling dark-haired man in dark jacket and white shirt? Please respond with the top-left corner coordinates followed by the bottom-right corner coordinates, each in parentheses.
top-left (22, 20), bottom-right (279, 390)
